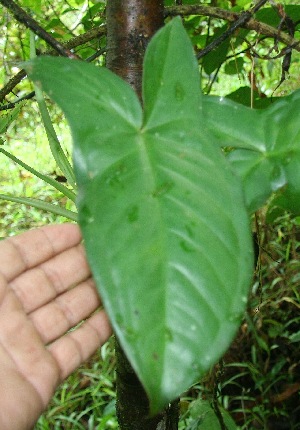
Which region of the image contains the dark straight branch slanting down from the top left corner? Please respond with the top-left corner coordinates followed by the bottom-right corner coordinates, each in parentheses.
top-left (0, 0), bottom-right (78, 58)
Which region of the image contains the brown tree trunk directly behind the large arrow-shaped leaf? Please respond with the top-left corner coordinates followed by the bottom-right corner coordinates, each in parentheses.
top-left (106, 0), bottom-right (178, 430)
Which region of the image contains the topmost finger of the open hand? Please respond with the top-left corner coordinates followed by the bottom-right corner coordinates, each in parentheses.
top-left (0, 223), bottom-right (81, 282)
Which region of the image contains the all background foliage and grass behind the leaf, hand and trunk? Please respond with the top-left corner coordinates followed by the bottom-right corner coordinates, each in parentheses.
top-left (0, 0), bottom-right (300, 430)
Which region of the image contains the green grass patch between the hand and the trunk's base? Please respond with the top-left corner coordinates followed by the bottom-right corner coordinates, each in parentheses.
top-left (35, 339), bottom-right (117, 430)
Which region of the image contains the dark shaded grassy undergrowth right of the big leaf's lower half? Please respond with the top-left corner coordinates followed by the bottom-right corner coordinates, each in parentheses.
top-left (202, 211), bottom-right (300, 430)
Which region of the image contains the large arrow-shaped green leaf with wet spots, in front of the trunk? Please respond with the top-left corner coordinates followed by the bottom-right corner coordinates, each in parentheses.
top-left (27, 19), bottom-right (253, 412)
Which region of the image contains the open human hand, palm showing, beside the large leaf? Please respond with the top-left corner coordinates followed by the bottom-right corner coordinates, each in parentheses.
top-left (0, 224), bottom-right (111, 430)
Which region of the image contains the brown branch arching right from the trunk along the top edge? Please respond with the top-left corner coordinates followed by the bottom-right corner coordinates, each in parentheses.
top-left (165, 5), bottom-right (300, 52)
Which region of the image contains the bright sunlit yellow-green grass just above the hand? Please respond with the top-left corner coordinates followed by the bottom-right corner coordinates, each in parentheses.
top-left (0, 107), bottom-right (75, 238)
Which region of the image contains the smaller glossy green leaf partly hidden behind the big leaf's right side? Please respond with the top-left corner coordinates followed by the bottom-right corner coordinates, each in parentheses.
top-left (203, 91), bottom-right (300, 213)
